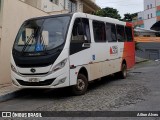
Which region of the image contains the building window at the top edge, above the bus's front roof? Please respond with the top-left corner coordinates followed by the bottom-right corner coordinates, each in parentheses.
top-left (68, 0), bottom-right (77, 12)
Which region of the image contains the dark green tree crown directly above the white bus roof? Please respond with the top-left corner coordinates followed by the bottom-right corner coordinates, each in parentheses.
top-left (94, 7), bottom-right (121, 20)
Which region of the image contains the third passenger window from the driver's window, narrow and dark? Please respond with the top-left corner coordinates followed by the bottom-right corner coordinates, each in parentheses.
top-left (117, 25), bottom-right (125, 42)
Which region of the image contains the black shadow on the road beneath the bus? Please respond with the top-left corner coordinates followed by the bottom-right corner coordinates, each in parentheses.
top-left (12, 75), bottom-right (120, 100)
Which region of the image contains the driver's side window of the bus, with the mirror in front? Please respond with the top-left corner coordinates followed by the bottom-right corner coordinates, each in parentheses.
top-left (71, 18), bottom-right (91, 43)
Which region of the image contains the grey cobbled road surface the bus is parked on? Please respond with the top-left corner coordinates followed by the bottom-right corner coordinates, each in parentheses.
top-left (0, 62), bottom-right (160, 120)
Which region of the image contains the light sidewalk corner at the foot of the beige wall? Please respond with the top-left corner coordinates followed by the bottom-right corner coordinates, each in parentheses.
top-left (0, 84), bottom-right (21, 102)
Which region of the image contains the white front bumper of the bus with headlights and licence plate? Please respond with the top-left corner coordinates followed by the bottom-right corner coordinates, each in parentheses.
top-left (11, 71), bottom-right (69, 88)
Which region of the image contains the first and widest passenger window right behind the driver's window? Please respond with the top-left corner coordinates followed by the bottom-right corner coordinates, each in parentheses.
top-left (93, 21), bottom-right (106, 42)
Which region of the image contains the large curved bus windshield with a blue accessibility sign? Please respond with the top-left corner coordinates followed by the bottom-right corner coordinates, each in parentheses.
top-left (13, 16), bottom-right (70, 53)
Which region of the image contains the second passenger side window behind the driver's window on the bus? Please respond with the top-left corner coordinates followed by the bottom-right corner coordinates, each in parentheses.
top-left (106, 23), bottom-right (117, 42)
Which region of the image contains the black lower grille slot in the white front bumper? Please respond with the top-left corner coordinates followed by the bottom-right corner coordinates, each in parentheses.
top-left (17, 79), bottom-right (55, 86)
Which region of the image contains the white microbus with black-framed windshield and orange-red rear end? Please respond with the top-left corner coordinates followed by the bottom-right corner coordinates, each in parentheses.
top-left (11, 13), bottom-right (135, 95)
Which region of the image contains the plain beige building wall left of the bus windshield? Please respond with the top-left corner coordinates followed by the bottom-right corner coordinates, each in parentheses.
top-left (0, 0), bottom-right (48, 84)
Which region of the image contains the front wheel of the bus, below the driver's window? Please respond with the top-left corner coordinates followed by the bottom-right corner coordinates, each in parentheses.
top-left (71, 74), bottom-right (88, 95)
